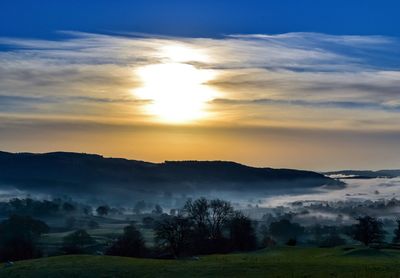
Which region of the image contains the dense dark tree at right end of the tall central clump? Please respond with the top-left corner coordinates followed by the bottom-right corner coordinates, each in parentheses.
top-left (229, 213), bottom-right (257, 251)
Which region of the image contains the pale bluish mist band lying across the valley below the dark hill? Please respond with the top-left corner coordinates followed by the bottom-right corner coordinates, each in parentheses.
top-left (0, 177), bottom-right (400, 225)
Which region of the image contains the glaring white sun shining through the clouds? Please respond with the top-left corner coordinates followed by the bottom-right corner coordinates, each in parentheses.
top-left (133, 43), bottom-right (216, 124)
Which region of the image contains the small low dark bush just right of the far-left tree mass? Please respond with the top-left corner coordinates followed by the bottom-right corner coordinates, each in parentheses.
top-left (62, 229), bottom-right (95, 254)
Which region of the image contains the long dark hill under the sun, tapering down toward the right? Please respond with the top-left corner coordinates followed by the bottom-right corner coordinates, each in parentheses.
top-left (0, 152), bottom-right (339, 197)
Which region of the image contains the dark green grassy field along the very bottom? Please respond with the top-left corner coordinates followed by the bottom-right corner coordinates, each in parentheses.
top-left (0, 247), bottom-right (400, 278)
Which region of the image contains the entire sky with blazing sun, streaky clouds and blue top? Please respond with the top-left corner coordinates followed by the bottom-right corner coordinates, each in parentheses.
top-left (0, 0), bottom-right (400, 170)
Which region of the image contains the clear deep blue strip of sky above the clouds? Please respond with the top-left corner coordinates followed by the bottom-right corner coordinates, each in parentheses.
top-left (0, 0), bottom-right (400, 38)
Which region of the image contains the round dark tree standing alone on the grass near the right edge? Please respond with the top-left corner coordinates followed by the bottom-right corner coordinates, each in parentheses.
top-left (351, 216), bottom-right (385, 246)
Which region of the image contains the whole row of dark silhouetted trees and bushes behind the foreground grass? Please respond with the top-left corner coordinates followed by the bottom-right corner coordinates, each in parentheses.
top-left (0, 198), bottom-right (400, 261)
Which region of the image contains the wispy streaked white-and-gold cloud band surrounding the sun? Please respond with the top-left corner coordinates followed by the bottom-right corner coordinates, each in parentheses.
top-left (0, 32), bottom-right (400, 130)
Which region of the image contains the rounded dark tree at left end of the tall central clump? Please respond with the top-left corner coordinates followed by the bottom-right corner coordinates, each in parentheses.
top-left (155, 216), bottom-right (193, 257)
